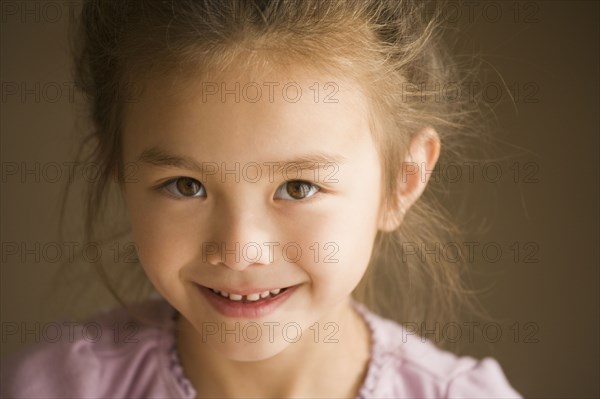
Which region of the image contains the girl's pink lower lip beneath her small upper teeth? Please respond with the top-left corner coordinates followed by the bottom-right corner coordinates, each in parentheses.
top-left (197, 285), bottom-right (298, 319)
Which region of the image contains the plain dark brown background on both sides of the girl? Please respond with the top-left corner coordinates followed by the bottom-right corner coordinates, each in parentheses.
top-left (0, 1), bottom-right (600, 397)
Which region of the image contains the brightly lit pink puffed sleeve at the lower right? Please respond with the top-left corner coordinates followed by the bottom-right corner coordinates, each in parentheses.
top-left (445, 358), bottom-right (522, 399)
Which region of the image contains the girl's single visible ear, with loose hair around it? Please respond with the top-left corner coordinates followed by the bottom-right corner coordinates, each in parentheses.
top-left (379, 127), bottom-right (440, 232)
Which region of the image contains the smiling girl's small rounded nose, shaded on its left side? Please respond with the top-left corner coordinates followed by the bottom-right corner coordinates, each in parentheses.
top-left (202, 205), bottom-right (276, 271)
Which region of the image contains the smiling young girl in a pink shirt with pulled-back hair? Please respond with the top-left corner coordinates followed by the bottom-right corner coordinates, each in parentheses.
top-left (2, 0), bottom-right (519, 398)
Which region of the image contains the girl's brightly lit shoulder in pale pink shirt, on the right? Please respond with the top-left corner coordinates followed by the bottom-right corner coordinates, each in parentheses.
top-left (357, 304), bottom-right (521, 398)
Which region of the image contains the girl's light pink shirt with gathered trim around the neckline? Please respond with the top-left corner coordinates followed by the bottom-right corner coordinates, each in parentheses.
top-left (0, 300), bottom-right (521, 399)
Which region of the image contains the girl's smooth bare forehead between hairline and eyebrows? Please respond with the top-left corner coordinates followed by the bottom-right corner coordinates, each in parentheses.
top-left (124, 69), bottom-right (371, 161)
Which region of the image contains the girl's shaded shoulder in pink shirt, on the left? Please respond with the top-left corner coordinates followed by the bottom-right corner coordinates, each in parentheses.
top-left (1, 299), bottom-right (192, 398)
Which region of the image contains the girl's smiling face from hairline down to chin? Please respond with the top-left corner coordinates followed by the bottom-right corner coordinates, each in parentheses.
top-left (123, 67), bottom-right (381, 360)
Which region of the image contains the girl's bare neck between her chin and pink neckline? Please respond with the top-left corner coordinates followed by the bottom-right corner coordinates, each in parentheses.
top-left (177, 302), bottom-right (370, 398)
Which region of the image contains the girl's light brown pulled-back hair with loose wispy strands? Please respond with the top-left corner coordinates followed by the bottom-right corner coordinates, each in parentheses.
top-left (61, 0), bottom-right (490, 348)
